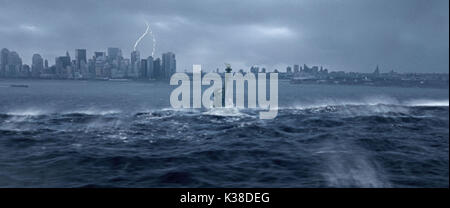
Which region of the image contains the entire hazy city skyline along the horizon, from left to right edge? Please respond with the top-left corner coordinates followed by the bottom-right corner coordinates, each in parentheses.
top-left (0, 47), bottom-right (448, 91)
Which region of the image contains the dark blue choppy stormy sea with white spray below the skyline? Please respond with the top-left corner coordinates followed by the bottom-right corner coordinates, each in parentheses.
top-left (0, 80), bottom-right (449, 188)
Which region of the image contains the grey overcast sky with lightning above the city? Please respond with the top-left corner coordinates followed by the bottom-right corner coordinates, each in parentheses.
top-left (0, 0), bottom-right (449, 73)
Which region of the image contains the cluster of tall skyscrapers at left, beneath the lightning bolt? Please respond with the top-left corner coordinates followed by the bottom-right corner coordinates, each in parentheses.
top-left (0, 47), bottom-right (176, 80)
